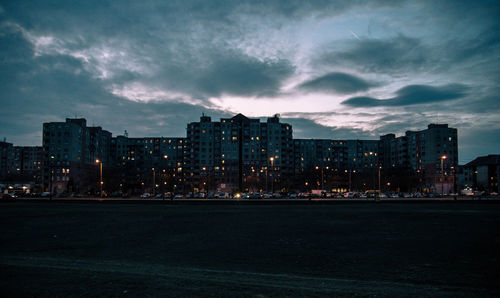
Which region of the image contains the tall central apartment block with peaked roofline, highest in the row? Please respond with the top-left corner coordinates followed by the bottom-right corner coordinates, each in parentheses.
top-left (186, 114), bottom-right (294, 191)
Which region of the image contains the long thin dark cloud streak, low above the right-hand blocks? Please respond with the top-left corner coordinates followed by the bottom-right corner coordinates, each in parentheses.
top-left (342, 84), bottom-right (468, 107)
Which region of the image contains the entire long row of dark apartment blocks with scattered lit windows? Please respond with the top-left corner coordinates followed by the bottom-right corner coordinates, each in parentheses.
top-left (0, 114), bottom-right (458, 194)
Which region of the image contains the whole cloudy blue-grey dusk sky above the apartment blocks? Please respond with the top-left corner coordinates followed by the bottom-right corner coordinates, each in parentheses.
top-left (0, 0), bottom-right (500, 163)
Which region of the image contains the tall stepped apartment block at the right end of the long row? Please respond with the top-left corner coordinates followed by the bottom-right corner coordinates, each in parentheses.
top-left (379, 124), bottom-right (458, 193)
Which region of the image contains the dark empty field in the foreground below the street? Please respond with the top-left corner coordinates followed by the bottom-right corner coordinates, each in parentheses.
top-left (0, 202), bottom-right (500, 297)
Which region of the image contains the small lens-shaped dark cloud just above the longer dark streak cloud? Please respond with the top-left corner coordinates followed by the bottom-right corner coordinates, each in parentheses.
top-left (299, 72), bottom-right (377, 94)
